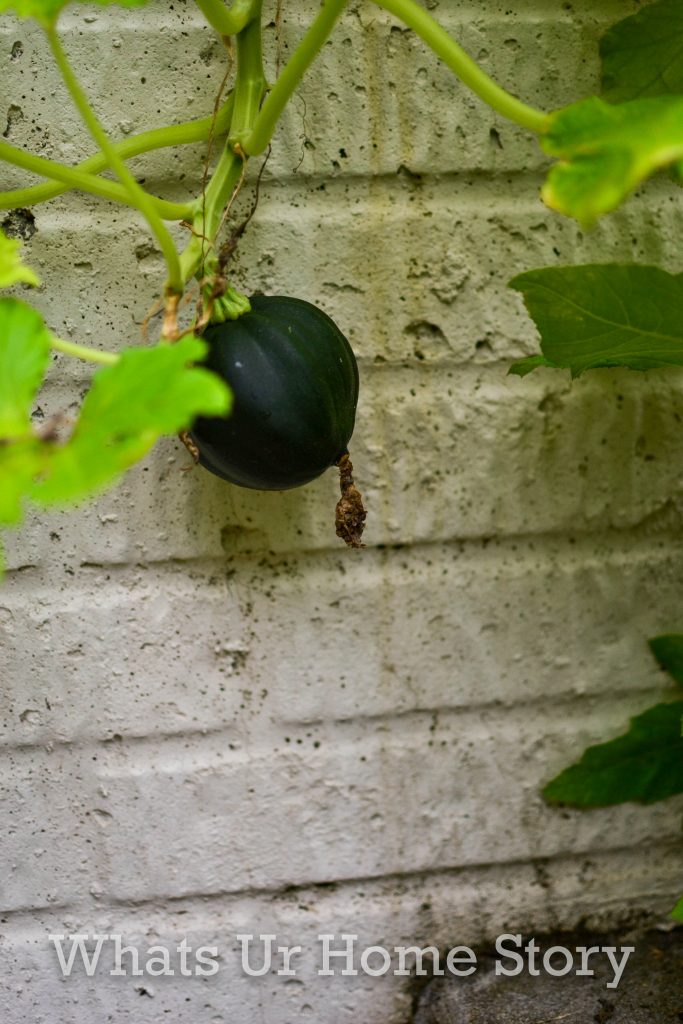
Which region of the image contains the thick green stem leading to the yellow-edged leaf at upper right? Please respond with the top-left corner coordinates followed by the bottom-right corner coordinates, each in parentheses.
top-left (373, 0), bottom-right (550, 134)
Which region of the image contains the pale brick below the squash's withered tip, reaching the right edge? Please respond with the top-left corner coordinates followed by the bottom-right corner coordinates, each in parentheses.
top-left (230, 541), bottom-right (681, 735)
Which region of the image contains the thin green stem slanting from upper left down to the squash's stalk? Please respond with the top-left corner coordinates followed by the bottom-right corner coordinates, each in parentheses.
top-left (45, 25), bottom-right (183, 294)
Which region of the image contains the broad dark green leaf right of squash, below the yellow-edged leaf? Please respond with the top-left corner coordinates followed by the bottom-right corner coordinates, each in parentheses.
top-left (510, 263), bottom-right (683, 377)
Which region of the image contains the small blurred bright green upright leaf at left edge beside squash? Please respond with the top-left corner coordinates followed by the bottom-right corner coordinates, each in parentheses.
top-left (0, 299), bottom-right (50, 439)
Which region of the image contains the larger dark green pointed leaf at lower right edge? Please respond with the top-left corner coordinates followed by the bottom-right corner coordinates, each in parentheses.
top-left (543, 700), bottom-right (683, 807)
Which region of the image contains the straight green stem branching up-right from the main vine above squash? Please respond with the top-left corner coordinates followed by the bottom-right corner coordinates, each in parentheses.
top-left (241, 0), bottom-right (348, 157)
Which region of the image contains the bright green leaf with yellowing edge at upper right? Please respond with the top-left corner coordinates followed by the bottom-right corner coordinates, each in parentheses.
top-left (541, 96), bottom-right (683, 227)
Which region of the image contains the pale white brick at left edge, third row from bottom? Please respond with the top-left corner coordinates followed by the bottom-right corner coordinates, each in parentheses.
top-left (0, 567), bottom-right (246, 745)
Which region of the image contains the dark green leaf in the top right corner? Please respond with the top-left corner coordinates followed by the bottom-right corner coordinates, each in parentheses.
top-left (600, 0), bottom-right (683, 103)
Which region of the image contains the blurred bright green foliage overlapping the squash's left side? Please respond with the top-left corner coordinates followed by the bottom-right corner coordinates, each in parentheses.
top-left (0, 284), bottom-right (230, 570)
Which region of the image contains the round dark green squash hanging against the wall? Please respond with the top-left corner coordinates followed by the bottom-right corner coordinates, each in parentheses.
top-left (189, 295), bottom-right (358, 490)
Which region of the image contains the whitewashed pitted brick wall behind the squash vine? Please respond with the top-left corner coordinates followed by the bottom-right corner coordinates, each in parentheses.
top-left (0, 0), bottom-right (683, 1024)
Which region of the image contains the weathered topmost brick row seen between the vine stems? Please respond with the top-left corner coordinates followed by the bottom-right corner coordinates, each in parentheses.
top-left (0, 3), bottom-right (637, 186)
